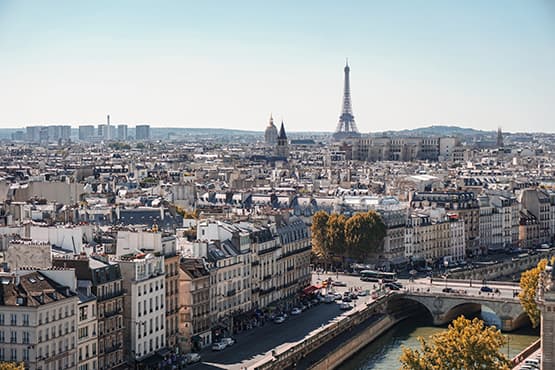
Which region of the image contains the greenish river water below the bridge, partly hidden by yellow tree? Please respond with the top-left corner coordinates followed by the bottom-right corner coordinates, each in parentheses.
top-left (339, 310), bottom-right (539, 370)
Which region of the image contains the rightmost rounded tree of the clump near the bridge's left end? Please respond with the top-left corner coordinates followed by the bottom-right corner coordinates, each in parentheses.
top-left (345, 211), bottom-right (386, 261)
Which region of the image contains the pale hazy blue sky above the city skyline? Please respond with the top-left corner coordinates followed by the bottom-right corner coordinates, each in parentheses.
top-left (0, 0), bottom-right (555, 132)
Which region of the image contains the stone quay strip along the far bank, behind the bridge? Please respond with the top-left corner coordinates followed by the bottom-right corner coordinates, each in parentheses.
top-left (448, 250), bottom-right (555, 281)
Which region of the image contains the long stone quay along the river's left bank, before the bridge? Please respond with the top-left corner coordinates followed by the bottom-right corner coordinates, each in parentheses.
top-left (248, 293), bottom-right (391, 370)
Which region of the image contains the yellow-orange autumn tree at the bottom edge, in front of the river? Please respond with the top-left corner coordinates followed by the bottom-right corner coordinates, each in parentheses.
top-left (400, 316), bottom-right (510, 370)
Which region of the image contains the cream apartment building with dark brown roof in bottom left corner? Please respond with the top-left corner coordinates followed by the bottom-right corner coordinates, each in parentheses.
top-left (0, 270), bottom-right (79, 370)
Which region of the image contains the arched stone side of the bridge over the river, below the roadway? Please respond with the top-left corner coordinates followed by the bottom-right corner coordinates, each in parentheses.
top-left (388, 291), bottom-right (529, 331)
